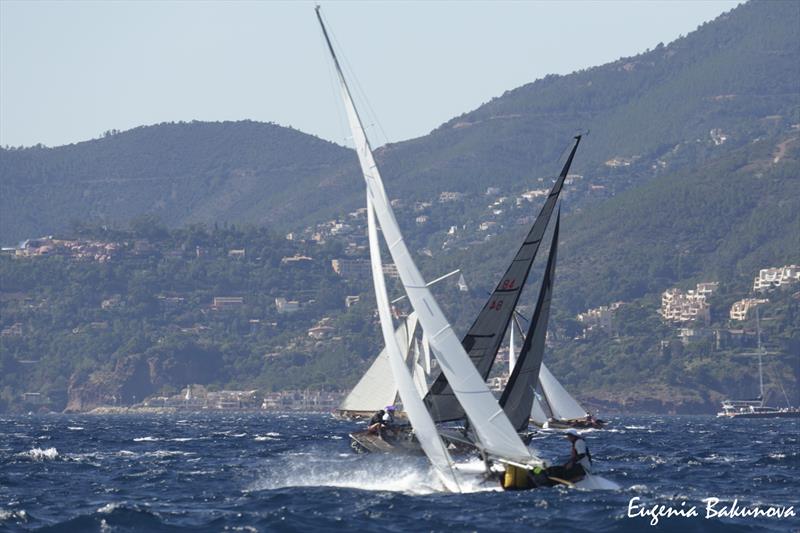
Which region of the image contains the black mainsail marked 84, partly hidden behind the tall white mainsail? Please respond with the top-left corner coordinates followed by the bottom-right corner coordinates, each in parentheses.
top-left (424, 135), bottom-right (581, 422)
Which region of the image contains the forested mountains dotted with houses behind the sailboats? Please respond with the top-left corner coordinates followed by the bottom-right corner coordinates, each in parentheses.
top-left (0, 1), bottom-right (800, 412)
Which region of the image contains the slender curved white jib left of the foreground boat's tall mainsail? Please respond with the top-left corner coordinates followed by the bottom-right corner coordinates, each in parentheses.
top-left (367, 196), bottom-right (461, 492)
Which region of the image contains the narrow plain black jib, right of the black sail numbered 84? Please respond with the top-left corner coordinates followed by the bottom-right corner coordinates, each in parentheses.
top-left (500, 211), bottom-right (561, 431)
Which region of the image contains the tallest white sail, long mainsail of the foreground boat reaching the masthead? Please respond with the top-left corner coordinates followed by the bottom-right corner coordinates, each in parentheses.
top-left (317, 12), bottom-right (541, 464)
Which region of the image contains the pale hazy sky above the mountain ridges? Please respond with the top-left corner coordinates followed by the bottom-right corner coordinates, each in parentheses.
top-left (0, 0), bottom-right (739, 146)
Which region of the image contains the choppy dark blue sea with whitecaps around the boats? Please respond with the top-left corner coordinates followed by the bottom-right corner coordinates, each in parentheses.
top-left (0, 413), bottom-right (800, 532)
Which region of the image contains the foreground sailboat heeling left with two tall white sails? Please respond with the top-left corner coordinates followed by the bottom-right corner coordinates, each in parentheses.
top-left (316, 7), bottom-right (618, 491)
